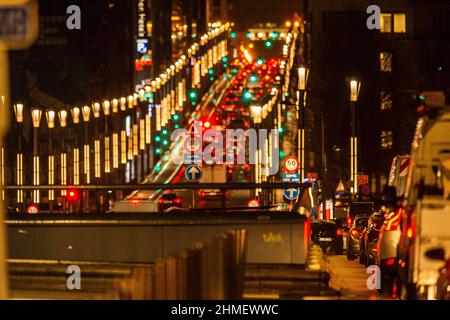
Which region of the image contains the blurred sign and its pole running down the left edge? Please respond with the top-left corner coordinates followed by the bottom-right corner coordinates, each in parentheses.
top-left (0, 0), bottom-right (39, 300)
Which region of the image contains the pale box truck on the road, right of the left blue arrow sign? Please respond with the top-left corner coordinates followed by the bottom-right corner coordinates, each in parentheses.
top-left (198, 164), bottom-right (228, 200)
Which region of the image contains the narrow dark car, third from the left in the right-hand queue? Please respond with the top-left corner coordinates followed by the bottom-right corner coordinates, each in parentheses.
top-left (359, 211), bottom-right (384, 267)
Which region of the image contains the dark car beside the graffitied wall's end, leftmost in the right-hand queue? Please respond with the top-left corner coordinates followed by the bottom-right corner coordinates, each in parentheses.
top-left (311, 220), bottom-right (344, 254)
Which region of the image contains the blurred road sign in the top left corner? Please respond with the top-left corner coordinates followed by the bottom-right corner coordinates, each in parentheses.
top-left (0, 0), bottom-right (39, 49)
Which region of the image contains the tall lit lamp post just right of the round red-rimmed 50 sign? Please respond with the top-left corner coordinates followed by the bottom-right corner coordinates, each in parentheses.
top-left (297, 66), bottom-right (309, 182)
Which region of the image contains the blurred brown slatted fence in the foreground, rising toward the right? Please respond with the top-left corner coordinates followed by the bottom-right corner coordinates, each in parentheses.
top-left (9, 229), bottom-right (247, 300)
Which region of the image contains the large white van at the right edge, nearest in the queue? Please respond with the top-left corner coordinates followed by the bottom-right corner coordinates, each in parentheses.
top-left (398, 109), bottom-right (450, 299)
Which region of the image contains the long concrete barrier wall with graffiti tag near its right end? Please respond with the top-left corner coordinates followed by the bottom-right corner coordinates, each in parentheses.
top-left (7, 210), bottom-right (309, 264)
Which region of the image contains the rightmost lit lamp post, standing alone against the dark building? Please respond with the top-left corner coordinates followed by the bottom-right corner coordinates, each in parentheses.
top-left (350, 79), bottom-right (361, 193)
